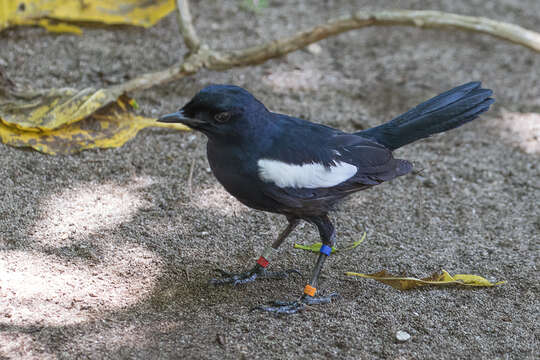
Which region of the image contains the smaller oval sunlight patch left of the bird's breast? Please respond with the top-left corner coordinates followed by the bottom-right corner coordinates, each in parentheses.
top-left (32, 177), bottom-right (153, 247)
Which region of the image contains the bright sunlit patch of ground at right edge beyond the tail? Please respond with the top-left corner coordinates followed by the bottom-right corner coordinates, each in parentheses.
top-left (495, 110), bottom-right (540, 154)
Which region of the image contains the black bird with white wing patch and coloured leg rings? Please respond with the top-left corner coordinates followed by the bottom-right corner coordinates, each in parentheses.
top-left (159, 82), bottom-right (494, 313)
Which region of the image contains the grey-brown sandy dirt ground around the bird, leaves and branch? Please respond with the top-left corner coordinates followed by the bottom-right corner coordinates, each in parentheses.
top-left (0, 0), bottom-right (540, 359)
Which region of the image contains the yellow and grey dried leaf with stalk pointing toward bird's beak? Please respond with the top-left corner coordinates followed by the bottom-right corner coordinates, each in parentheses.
top-left (0, 93), bottom-right (189, 155)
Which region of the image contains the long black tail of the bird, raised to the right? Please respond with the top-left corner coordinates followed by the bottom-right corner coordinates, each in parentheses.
top-left (356, 82), bottom-right (495, 150)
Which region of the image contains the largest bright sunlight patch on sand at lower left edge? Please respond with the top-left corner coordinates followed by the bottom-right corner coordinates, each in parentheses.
top-left (0, 244), bottom-right (161, 326)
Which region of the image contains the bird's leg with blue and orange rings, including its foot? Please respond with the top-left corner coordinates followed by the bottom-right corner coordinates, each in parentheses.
top-left (256, 215), bottom-right (338, 314)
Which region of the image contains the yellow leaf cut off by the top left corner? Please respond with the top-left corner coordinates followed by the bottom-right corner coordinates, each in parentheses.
top-left (0, 0), bottom-right (175, 33)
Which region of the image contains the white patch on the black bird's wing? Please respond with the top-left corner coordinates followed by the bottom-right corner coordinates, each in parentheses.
top-left (257, 159), bottom-right (358, 189)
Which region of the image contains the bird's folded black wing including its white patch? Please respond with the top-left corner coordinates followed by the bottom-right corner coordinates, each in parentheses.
top-left (258, 133), bottom-right (412, 211)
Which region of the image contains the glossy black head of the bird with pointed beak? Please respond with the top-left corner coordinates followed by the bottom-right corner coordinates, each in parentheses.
top-left (158, 85), bottom-right (268, 139)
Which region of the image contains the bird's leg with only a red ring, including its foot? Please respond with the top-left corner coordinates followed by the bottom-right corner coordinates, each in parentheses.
top-left (210, 217), bottom-right (300, 285)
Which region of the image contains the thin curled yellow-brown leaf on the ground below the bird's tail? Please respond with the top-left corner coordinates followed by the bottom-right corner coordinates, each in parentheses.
top-left (345, 270), bottom-right (506, 290)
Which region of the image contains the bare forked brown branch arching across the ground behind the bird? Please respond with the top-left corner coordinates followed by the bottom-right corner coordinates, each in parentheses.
top-left (116, 9), bottom-right (540, 92)
